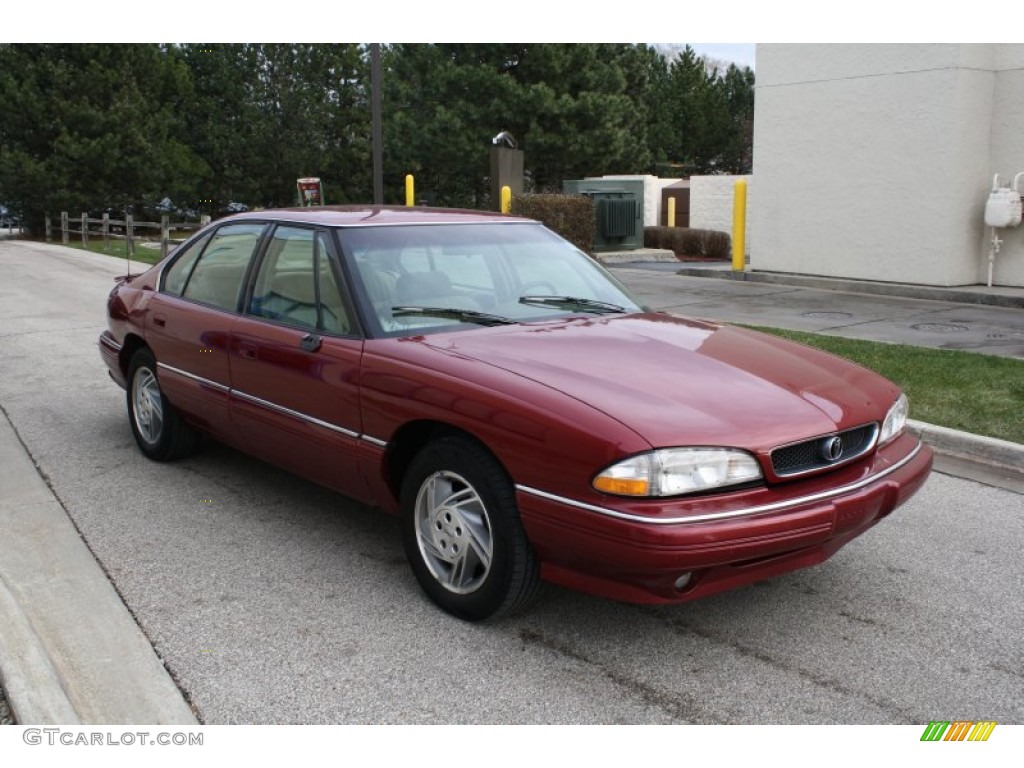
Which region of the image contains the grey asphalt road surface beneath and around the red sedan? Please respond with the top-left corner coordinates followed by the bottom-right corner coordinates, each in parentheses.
top-left (0, 242), bottom-right (1024, 724)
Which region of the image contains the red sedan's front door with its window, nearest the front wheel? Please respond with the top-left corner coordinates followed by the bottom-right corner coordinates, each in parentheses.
top-left (230, 225), bottom-right (369, 501)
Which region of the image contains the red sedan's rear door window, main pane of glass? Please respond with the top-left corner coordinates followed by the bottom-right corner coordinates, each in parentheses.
top-left (182, 224), bottom-right (263, 312)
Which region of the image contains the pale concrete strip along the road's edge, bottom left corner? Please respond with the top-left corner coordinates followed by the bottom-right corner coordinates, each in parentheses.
top-left (0, 412), bottom-right (198, 725)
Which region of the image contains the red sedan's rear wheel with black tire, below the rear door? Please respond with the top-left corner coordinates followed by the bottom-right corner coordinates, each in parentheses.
top-left (128, 347), bottom-right (199, 462)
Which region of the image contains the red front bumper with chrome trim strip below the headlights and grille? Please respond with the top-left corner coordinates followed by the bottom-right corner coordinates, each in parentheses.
top-left (517, 435), bottom-right (932, 603)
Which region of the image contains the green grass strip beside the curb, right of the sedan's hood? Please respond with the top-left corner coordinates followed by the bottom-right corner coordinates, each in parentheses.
top-left (752, 327), bottom-right (1024, 443)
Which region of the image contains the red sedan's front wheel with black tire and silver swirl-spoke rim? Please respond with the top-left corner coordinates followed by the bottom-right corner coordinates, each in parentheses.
top-left (401, 437), bottom-right (541, 622)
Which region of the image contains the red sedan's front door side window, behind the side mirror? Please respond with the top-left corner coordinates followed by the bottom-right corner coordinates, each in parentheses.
top-left (248, 226), bottom-right (349, 334)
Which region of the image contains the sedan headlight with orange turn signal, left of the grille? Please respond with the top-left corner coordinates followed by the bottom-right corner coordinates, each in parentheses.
top-left (594, 447), bottom-right (762, 497)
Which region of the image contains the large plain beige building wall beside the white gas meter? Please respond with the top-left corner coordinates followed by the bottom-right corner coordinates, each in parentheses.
top-left (751, 44), bottom-right (1024, 286)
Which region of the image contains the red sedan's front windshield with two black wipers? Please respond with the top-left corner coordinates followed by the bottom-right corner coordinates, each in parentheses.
top-left (340, 222), bottom-right (646, 336)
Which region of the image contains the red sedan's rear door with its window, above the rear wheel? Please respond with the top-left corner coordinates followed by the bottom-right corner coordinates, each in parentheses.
top-left (145, 223), bottom-right (266, 439)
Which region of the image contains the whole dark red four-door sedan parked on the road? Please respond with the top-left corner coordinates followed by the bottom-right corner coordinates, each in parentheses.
top-left (99, 207), bottom-right (932, 620)
